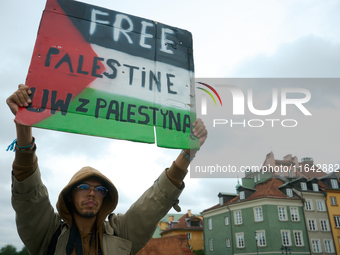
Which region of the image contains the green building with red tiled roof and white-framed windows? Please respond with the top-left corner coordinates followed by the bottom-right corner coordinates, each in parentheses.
top-left (202, 178), bottom-right (310, 255)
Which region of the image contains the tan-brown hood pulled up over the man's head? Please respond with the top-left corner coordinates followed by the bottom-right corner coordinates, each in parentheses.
top-left (56, 166), bottom-right (118, 228)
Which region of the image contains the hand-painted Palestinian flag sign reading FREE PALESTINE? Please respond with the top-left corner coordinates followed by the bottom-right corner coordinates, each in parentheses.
top-left (16, 0), bottom-right (198, 148)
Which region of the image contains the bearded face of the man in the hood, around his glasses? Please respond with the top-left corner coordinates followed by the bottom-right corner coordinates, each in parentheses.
top-left (72, 178), bottom-right (104, 218)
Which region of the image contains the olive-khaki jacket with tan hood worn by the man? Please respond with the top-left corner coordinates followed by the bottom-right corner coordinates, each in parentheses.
top-left (12, 146), bottom-right (185, 255)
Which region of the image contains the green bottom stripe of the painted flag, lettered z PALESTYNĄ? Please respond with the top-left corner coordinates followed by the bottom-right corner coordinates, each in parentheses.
top-left (34, 88), bottom-right (198, 149)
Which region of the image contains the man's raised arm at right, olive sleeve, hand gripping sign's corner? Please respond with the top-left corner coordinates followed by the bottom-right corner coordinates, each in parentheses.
top-left (109, 119), bottom-right (207, 254)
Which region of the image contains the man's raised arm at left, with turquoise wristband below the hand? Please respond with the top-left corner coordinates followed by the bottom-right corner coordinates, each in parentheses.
top-left (6, 84), bottom-right (60, 255)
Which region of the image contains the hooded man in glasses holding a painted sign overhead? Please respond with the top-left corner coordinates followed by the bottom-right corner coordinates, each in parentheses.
top-left (7, 85), bottom-right (207, 255)
